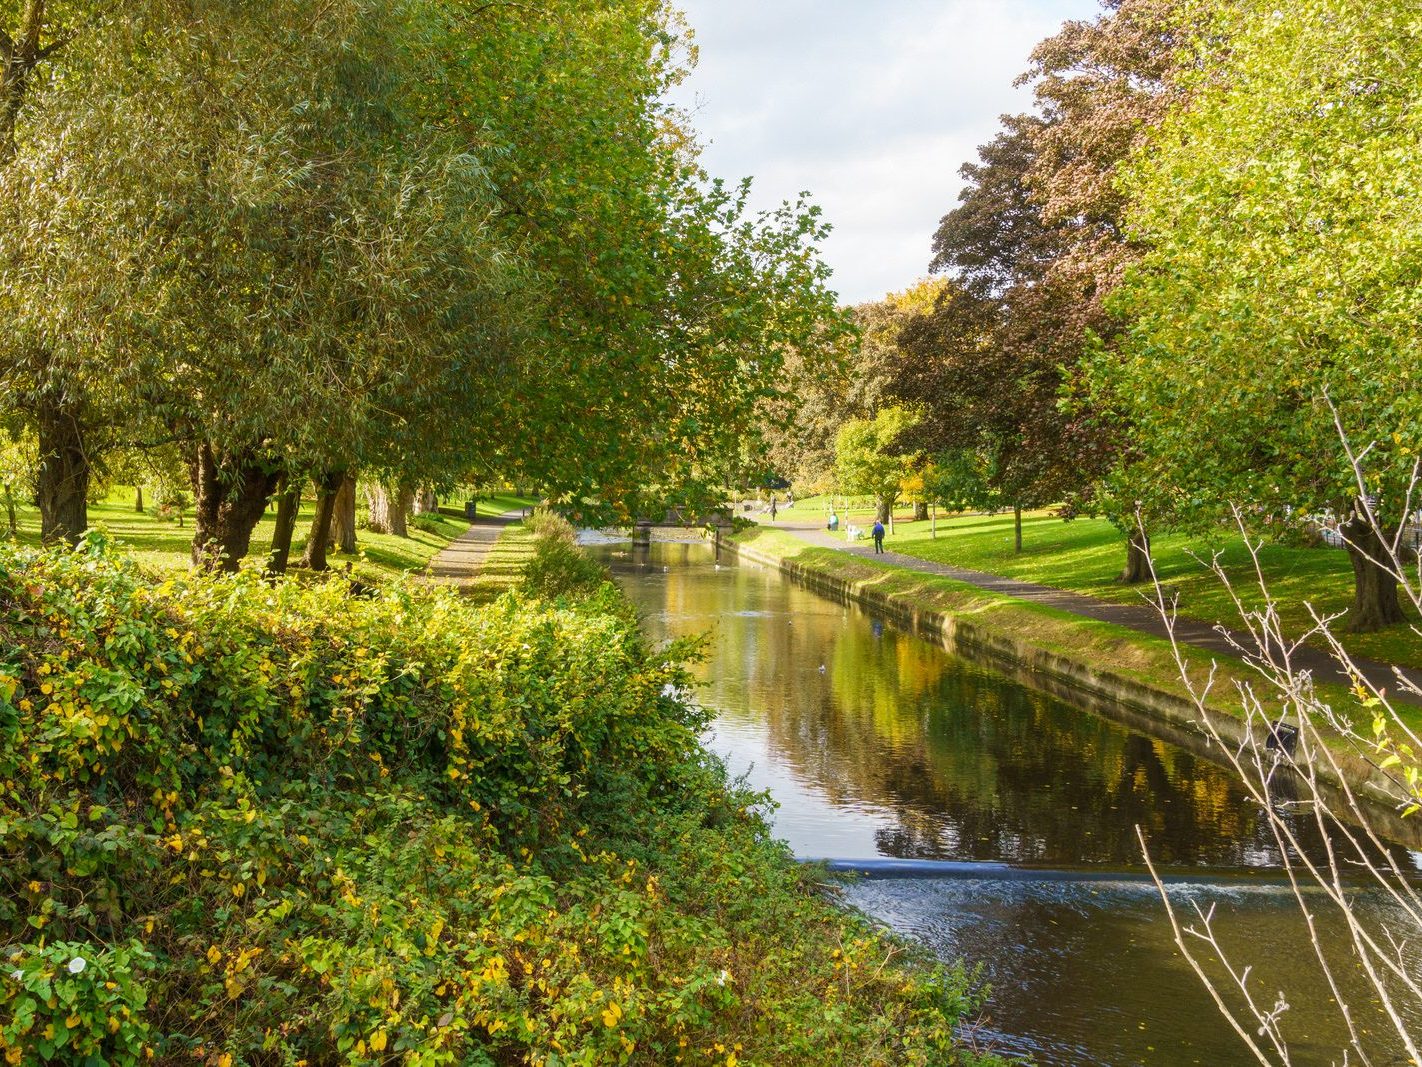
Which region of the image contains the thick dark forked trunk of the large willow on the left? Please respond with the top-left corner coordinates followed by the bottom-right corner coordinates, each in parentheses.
top-left (189, 441), bottom-right (277, 572)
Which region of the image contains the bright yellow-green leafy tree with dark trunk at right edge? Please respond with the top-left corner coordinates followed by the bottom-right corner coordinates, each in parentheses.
top-left (1098, 0), bottom-right (1422, 630)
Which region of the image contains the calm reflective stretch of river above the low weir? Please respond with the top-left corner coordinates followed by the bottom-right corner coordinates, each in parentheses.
top-left (599, 542), bottom-right (1412, 869)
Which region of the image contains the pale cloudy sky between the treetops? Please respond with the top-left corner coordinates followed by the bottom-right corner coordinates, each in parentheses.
top-left (675, 0), bottom-right (1099, 303)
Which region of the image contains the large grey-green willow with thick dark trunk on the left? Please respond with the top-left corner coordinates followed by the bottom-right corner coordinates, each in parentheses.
top-left (7, 0), bottom-right (523, 566)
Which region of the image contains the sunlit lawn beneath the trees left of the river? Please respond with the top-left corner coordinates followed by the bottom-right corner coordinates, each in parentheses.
top-left (5, 487), bottom-right (532, 580)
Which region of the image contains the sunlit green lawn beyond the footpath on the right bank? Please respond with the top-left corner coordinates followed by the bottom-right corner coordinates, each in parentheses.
top-left (781, 497), bottom-right (1422, 667)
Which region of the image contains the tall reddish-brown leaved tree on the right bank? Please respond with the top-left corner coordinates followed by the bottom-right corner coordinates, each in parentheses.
top-left (890, 0), bottom-right (1175, 580)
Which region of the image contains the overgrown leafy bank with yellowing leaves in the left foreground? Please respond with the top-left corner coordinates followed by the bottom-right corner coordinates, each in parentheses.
top-left (0, 524), bottom-right (1001, 1067)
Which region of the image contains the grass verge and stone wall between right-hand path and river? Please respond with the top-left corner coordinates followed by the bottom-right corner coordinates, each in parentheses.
top-left (722, 529), bottom-right (1422, 848)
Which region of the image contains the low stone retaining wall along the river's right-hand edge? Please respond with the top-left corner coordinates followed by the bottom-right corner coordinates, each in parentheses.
top-left (712, 535), bottom-right (1422, 845)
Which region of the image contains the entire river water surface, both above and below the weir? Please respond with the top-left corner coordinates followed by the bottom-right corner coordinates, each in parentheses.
top-left (589, 542), bottom-right (1422, 1066)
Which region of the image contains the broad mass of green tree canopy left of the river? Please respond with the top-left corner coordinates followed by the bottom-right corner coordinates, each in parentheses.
top-left (0, 0), bottom-right (836, 566)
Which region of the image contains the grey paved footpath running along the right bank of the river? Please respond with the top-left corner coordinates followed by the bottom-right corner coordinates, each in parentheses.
top-left (759, 516), bottom-right (1422, 704)
